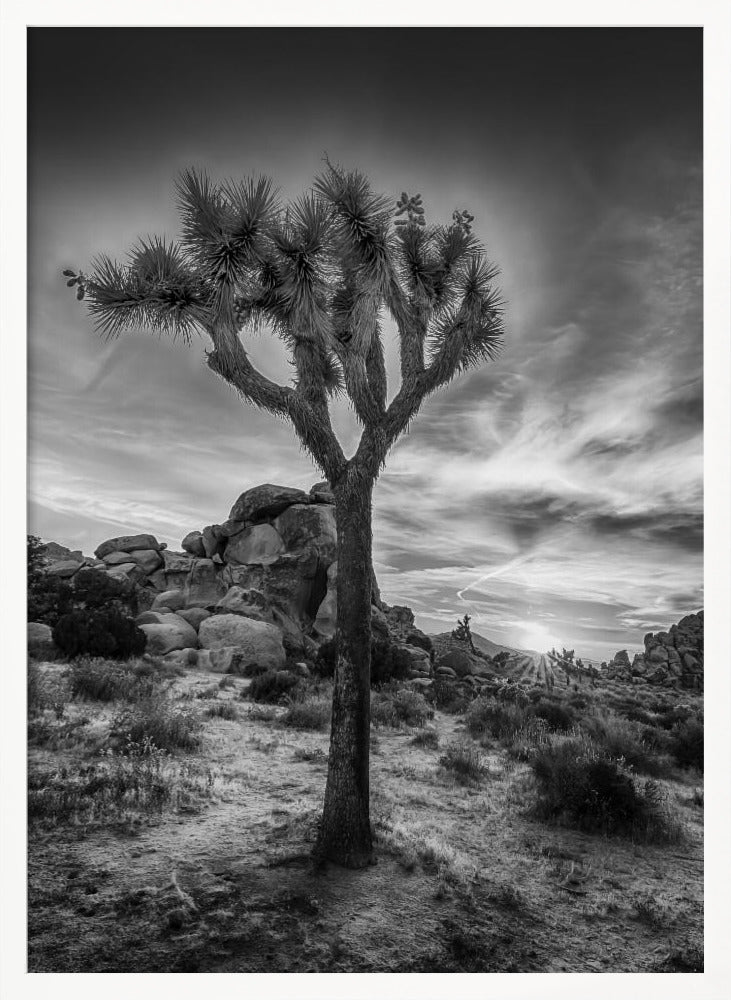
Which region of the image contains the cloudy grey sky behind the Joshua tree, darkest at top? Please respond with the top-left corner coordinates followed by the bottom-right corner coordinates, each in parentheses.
top-left (28, 28), bottom-right (703, 661)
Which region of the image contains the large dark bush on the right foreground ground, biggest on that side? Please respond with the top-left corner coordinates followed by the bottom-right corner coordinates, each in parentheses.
top-left (531, 739), bottom-right (680, 842)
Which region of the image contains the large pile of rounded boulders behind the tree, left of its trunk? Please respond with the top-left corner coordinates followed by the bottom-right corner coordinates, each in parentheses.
top-left (30, 483), bottom-right (348, 670)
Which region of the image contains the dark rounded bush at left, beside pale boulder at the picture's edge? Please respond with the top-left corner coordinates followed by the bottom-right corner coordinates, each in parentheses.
top-left (53, 607), bottom-right (147, 660)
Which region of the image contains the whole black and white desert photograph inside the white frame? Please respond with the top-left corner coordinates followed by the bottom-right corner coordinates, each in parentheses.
top-left (3, 8), bottom-right (729, 997)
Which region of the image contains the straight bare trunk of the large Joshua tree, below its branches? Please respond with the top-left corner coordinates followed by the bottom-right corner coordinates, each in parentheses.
top-left (315, 466), bottom-right (373, 868)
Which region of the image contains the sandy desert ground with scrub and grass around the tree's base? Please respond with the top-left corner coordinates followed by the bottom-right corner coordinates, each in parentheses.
top-left (28, 659), bottom-right (703, 972)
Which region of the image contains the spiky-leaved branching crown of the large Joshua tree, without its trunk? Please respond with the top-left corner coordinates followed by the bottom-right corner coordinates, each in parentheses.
top-left (64, 160), bottom-right (502, 467)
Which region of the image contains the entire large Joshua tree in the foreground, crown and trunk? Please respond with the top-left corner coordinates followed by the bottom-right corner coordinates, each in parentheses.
top-left (64, 161), bottom-right (503, 867)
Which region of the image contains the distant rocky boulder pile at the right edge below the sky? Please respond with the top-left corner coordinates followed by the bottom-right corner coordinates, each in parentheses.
top-left (602, 611), bottom-right (703, 690)
